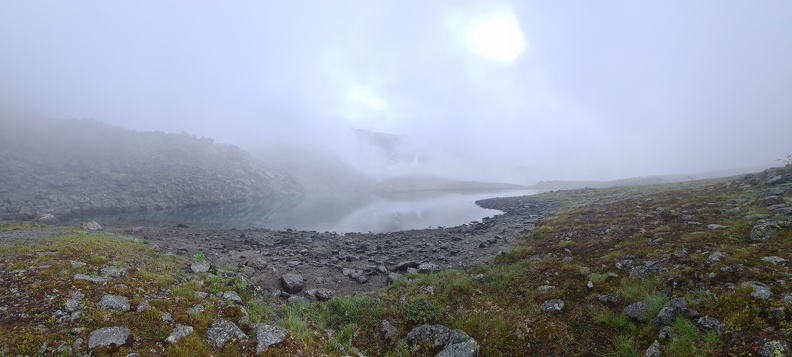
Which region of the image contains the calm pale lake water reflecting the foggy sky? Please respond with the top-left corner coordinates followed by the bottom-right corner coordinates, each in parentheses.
top-left (80, 191), bottom-right (538, 233)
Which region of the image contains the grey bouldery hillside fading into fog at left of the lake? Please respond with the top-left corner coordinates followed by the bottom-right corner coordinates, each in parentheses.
top-left (0, 114), bottom-right (300, 220)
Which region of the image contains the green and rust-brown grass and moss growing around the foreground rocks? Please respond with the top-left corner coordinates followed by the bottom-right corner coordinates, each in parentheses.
top-left (0, 168), bottom-right (792, 356)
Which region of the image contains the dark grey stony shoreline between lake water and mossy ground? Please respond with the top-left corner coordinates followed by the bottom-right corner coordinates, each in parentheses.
top-left (0, 196), bottom-right (558, 298)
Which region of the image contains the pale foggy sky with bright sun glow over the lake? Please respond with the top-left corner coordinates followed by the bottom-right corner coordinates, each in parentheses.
top-left (0, 0), bottom-right (792, 179)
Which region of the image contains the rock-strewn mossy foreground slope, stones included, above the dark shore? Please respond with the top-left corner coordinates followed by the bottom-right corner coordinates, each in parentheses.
top-left (0, 166), bottom-right (792, 357)
